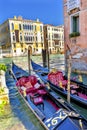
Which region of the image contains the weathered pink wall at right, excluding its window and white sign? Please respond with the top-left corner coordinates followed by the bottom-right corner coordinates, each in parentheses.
top-left (64, 0), bottom-right (87, 71)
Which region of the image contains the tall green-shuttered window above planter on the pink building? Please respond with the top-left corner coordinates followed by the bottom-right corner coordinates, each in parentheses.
top-left (71, 14), bottom-right (79, 33)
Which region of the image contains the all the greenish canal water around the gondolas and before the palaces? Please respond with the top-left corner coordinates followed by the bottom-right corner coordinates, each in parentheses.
top-left (0, 54), bottom-right (87, 130)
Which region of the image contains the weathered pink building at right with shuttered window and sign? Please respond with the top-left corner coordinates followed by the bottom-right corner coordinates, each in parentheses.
top-left (64, 0), bottom-right (87, 71)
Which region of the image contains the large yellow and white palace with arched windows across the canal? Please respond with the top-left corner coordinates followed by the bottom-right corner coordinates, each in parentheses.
top-left (0, 16), bottom-right (44, 56)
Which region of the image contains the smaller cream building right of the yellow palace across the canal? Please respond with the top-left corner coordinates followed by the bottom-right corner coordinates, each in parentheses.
top-left (44, 24), bottom-right (64, 53)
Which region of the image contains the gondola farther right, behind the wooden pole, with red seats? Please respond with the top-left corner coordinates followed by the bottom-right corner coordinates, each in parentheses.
top-left (31, 60), bottom-right (87, 107)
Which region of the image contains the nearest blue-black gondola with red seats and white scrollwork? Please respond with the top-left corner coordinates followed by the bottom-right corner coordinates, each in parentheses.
top-left (9, 64), bottom-right (87, 130)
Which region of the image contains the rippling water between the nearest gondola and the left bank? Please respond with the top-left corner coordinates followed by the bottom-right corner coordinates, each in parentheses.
top-left (0, 66), bottom-right (44, 130)
